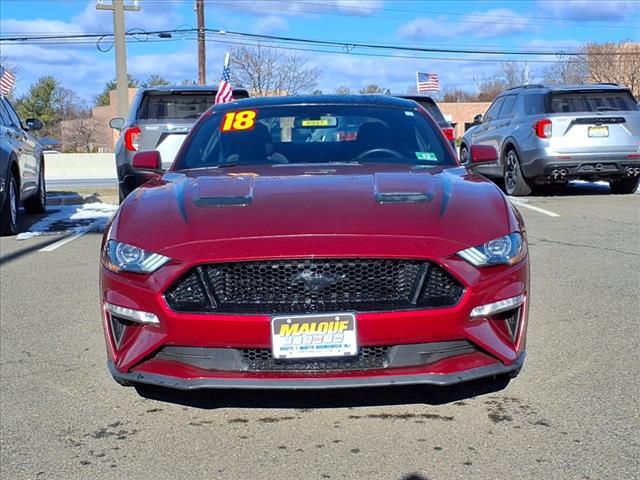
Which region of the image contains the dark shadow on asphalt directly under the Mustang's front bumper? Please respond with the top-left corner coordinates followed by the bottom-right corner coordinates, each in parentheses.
top-left (135, 376), bottom-right (509, 410)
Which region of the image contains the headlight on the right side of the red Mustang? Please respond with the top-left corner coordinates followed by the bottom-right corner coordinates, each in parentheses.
top-left (458, 232), bottom-right (527, 267)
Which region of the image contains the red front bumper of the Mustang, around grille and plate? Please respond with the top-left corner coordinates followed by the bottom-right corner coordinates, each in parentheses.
top-left (101, 244), bottom-right (529, 389)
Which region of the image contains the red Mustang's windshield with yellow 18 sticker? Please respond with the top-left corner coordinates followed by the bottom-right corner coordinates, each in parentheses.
top-left (174, 105), bottom-right (456, 170)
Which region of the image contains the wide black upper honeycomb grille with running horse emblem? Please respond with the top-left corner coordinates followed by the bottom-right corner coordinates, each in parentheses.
top-left (165, 259), bottom-right (464, 314)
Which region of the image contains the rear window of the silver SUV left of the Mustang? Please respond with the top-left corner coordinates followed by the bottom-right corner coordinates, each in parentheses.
top-left (138, 92), bottom-right (246, 120)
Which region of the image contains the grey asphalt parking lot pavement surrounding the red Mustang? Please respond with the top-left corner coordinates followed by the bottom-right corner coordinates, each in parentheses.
top-left (0, 187), bottom-right (640, 480)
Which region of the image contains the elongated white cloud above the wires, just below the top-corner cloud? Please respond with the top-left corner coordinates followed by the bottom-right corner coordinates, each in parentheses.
top-left (398, 8), bottom-right (536, 40)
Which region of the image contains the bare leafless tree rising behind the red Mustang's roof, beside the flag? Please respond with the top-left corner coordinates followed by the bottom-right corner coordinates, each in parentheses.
top-left (231, 46), bottom-right (320, 96)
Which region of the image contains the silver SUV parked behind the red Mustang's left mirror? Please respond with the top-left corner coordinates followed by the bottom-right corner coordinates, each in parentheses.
top-left (109, 86), bottom-right (249, 201)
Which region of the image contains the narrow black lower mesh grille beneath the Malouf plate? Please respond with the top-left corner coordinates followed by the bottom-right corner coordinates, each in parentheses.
top-left (241, 347), bottom-right (391, 372)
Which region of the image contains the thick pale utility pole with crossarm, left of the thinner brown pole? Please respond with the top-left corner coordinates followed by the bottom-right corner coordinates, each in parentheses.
top-left (96, 0), bottom-right (140, 118)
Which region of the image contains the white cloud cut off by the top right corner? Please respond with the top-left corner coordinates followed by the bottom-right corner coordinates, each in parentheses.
top-left (537, 0), bottom-right (640, 20)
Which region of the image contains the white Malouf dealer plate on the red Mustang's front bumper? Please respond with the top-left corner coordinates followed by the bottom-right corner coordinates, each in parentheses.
top-left (271, 313), bottom-right (358, 359)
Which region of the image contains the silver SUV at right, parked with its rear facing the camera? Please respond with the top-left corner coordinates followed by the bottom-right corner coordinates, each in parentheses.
top-left (460, 84), bottom-right (640, 195)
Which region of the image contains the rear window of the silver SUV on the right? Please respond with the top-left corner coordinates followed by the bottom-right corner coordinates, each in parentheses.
top-left (550, 90), bottom-right (638, 113)
